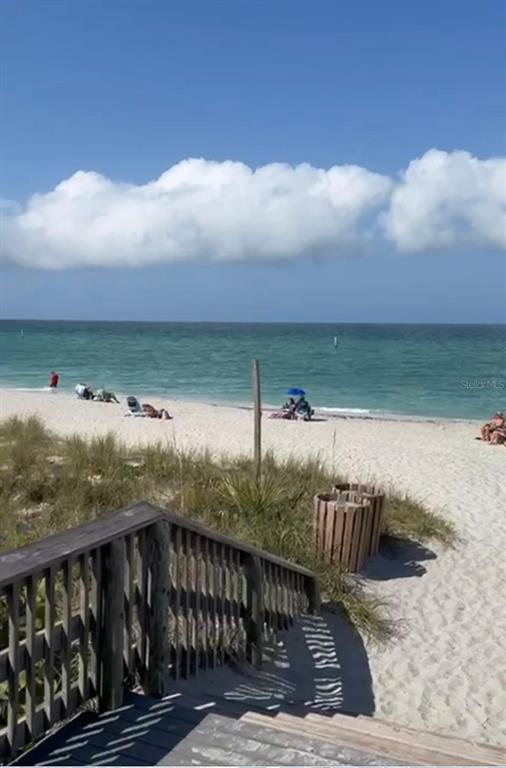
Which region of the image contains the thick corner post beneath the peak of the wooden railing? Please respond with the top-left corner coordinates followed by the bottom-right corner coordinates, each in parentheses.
top-left (143, 520), bottom-right (170, 698)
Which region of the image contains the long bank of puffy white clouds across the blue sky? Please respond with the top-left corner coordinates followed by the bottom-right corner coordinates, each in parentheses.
top-left (0, 150), bottom-right (506, 269)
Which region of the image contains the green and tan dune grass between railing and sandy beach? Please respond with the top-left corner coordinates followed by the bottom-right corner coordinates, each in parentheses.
top-left (0, 417), bottom-right (455, 641)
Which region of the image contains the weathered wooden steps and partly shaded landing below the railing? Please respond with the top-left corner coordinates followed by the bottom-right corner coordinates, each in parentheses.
top-left (18, 693), bottom-right (506, 766)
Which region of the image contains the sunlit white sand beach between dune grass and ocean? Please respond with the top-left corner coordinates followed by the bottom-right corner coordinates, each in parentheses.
top-left (0, 390), bottom-right (506, 745)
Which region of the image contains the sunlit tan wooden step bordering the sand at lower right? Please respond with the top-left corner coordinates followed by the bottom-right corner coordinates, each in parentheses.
top-left (241, 713), bottom-right (501, 765)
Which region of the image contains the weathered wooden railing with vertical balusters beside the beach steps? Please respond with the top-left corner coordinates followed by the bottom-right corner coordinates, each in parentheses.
top-left (0, 503), bottom-right (319, 760)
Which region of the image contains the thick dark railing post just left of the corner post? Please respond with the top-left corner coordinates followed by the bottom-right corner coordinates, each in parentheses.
top-left (98, 539), bottom-right (126, 712)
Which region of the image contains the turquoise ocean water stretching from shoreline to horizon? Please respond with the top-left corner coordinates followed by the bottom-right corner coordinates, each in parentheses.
top-left (0, 320), bottom-right (506, 419)
